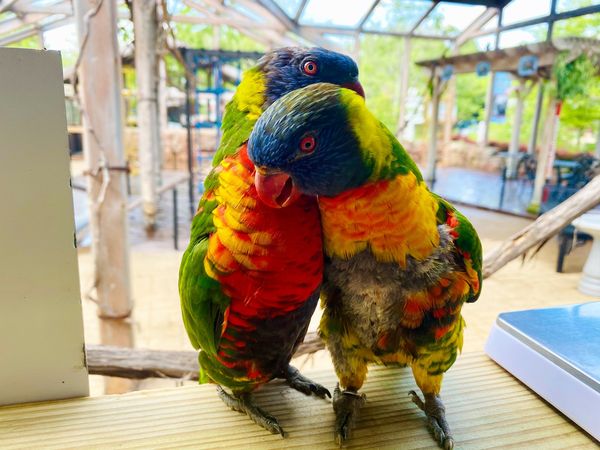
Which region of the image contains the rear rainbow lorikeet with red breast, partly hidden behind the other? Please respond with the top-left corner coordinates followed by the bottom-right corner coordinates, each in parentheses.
top-left (179, 48), bottom-right (362, 435)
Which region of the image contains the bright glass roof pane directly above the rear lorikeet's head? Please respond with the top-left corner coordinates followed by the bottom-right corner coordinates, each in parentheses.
top-left (300, 0), bottom-right (374, 28)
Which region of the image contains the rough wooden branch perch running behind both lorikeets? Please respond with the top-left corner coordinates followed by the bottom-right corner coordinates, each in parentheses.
top-left (86, 176), bottom-right (600, 380)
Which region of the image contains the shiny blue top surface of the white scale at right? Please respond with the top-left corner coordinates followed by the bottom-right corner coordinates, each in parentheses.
top-left (497, 302), bottom-right (600, 389)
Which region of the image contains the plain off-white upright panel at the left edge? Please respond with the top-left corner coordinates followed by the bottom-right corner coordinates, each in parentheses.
top-left (0, 48), bottom-right (88, 404)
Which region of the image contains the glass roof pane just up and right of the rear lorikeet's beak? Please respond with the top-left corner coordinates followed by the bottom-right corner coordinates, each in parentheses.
top-left (364, 0), bottom-right (433, 33)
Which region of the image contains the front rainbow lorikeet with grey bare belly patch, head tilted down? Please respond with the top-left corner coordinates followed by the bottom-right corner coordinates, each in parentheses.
top-left (248, 83), bottom-right (481, 448)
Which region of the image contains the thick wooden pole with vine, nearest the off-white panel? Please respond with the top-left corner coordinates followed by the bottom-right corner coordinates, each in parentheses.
top-left (74, 0), bottom-right (133, 392)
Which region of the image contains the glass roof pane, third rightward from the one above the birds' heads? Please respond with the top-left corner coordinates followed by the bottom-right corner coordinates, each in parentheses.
top-left (417, 3), bottom-right (485, 36)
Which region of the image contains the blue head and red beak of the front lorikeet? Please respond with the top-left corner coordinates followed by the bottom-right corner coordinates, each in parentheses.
top-left (248, 83), bottom-right (376, 207)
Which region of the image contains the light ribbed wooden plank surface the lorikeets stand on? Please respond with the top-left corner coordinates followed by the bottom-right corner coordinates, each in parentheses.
top-left (0, 353), bottom-right (598, 449)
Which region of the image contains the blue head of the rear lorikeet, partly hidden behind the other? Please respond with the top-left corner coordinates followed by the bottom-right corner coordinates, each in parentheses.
top-left (258, 47), bottom-right (364, 104)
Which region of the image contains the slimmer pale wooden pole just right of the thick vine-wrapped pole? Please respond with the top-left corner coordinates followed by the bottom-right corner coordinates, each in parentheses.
top-left (133, 0), bottom-right (161, 232)
